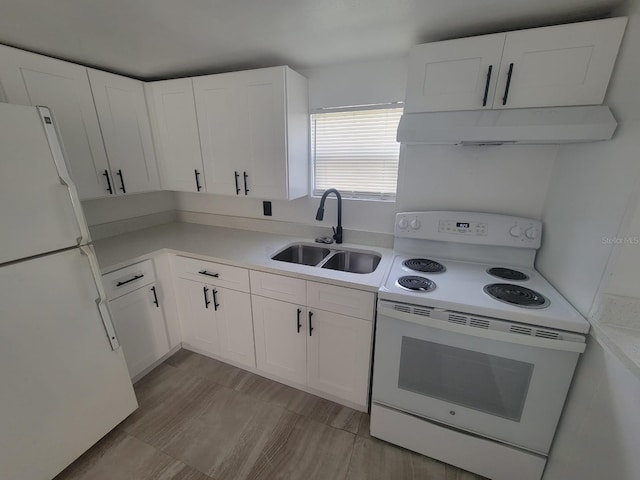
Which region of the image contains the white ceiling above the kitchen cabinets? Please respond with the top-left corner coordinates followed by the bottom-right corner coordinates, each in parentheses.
top-left (0, 0), bottom-right (621, 79)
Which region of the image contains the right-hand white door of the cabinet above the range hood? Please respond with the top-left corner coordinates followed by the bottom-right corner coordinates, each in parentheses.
top-left (493, 18), bottom-right (627, 108)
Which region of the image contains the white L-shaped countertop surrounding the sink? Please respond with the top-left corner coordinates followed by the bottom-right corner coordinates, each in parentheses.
top-left (93, 222), bottom-right (393, 292)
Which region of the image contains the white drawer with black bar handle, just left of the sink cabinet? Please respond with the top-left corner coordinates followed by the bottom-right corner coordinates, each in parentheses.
top-left (174, 255), bottom-right (249, 293)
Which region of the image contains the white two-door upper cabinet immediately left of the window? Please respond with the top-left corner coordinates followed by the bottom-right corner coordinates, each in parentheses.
top-left (193, 67), bottom-right (309, 199)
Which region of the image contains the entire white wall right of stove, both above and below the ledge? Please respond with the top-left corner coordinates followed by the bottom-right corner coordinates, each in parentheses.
top-left (537, 0), bottom-right (640, 480)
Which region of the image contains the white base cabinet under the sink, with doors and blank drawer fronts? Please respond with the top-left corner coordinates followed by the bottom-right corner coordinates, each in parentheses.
top-left (250, 271), bottom-right (375, 410)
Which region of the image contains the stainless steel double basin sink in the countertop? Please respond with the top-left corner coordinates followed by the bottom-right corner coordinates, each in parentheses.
top-left (271, 243), bottom-right (381, 273)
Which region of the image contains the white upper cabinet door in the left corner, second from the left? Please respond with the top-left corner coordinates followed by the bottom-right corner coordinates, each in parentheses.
top-left (88, 69), bottom-right (160, 193)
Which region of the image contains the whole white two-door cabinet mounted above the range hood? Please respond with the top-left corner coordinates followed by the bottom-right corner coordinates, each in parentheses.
top-left (405, 17), bottom-right (627, 113)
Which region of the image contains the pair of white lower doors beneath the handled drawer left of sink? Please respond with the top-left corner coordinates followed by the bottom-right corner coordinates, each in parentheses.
top-left (176, 278), bottom-right (255, 368)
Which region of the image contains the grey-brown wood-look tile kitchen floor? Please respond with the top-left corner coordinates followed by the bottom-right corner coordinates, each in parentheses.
top-left (54, 350), bottom-right (481, 480)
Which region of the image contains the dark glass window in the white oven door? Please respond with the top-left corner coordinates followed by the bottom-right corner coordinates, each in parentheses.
top-left (398, 337), bottom-right (533, 422)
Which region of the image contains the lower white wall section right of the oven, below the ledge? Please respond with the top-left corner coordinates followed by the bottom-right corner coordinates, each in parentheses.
top-left (543, 339), bottom-right (640, 480)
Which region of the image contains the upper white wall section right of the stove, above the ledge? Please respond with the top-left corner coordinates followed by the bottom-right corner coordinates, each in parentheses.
top-left (537, 1), bottom-right (640, 316)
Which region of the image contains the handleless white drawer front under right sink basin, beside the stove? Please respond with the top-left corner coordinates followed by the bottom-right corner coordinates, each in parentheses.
top-left (307, 282), bottom-right (375, 321)
